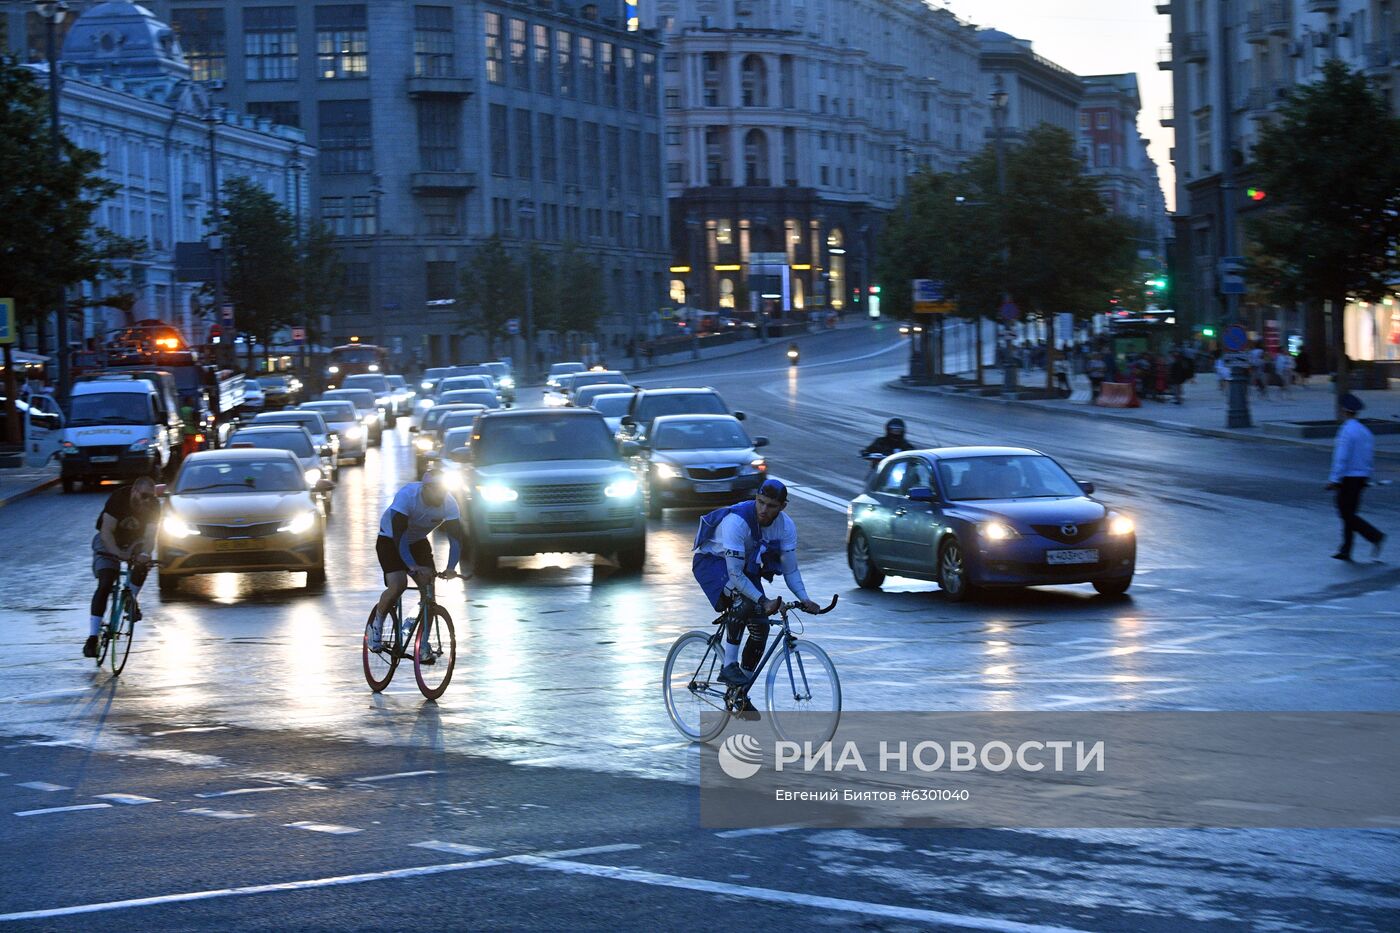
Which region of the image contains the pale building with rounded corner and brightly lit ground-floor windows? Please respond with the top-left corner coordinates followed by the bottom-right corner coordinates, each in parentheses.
top-left (643, 0), bottom-right (987, 312)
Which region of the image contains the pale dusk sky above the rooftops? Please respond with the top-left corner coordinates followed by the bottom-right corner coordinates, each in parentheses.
top-left (944, 0), bottom-right (1176, 210)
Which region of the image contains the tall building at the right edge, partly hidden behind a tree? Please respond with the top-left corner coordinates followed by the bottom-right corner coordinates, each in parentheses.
top-left (1156, 0), bottom-right (1400, 360)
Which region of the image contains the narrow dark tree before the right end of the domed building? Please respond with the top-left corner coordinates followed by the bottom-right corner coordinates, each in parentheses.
top-left (213, 178), bottom-right (304, 368)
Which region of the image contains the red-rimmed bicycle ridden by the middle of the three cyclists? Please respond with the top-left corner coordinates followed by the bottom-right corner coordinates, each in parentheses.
top-left (361, 573), bottom-right (458, 700)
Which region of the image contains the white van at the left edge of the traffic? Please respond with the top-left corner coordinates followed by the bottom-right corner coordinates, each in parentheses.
top-left (59, 377), bottom-right (181, 492)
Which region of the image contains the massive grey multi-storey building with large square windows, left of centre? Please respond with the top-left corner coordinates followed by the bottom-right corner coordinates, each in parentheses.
top-left (144, 0), bottom-right (669, 364)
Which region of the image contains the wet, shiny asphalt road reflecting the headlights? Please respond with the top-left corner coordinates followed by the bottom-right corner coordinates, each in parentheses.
top-left (0, 318), bottom-right (1400, 930)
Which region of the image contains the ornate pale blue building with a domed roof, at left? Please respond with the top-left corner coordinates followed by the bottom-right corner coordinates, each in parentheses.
top-left (0, 0), bottom-right (315, 342)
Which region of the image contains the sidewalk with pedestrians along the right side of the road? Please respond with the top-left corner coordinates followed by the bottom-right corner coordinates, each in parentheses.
top-left (889, 368), bottom-right (1400, 459)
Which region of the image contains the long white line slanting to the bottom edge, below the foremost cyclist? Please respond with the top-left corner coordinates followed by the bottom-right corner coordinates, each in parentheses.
top-left (504, 855), bottom-right (1082, 933)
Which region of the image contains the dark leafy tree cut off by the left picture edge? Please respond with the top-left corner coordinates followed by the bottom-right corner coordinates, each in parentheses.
top-left (0, 56), bottom-right (139, 437)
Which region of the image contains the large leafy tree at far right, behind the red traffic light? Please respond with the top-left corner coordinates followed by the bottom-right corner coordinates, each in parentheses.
top-left (1247, 59), bottom-right (1400, 396)
